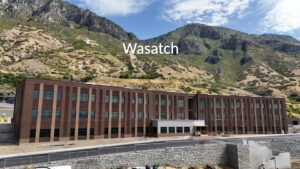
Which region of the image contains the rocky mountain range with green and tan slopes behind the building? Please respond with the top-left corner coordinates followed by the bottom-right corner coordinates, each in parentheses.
top-left (0, 0), bottom-right (300, 114)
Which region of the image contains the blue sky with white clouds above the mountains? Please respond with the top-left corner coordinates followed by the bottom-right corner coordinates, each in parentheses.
top-left (67, 0), bottom-right (300, 40)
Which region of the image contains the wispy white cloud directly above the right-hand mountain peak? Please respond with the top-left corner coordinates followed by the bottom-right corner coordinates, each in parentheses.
top-left (162, 0), bottom-right (253, 26)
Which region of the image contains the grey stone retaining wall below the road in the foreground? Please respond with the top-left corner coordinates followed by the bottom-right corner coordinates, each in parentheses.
top-left (18, 144), bottom-right (250, 169)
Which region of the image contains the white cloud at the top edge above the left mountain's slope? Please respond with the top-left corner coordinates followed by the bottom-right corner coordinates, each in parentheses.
top-left (78, 0), bottom-right (151, 16)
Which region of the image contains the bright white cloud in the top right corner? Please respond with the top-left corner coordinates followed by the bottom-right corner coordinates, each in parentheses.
top-left (261, 0), bottom-right (300, 33)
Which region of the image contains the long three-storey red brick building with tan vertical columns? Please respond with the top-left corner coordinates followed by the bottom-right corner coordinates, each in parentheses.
top-left (13, 78), bottom-right (287, 143)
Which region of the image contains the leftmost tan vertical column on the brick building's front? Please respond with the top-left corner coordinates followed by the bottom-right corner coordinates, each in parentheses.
top-left (35, 83), bottom-right (44, 143)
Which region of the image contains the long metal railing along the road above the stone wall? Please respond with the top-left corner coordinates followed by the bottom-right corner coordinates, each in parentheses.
top-left (0, 140), bottom-right (198, 168)
